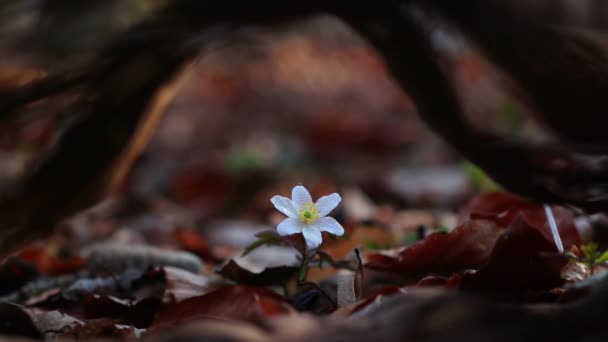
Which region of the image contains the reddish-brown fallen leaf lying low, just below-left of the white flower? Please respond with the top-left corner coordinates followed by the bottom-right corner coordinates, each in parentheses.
top-left (150, 285), bottom-right (294, 330)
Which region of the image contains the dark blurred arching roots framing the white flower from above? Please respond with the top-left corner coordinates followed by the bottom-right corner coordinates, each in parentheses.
top-left (0, 0), bottom-right (608, 255)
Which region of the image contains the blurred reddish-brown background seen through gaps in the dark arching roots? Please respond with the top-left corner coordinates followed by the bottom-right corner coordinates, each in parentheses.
top-left (0, 0), bottom-right (608, 232)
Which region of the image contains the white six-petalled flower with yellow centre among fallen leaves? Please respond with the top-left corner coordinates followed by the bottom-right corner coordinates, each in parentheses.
top-left (270, 185), bottom-right (344, 249)
